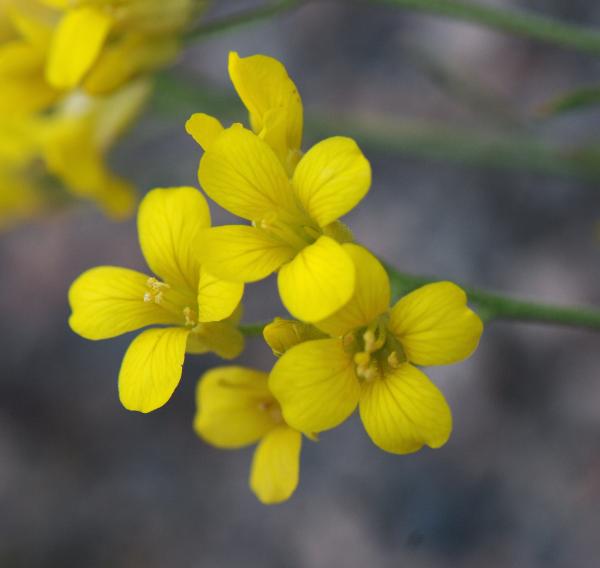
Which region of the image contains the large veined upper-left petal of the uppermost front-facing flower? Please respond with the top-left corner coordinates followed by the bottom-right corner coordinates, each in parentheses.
top-left (198, 124), bottom-right (294, 221)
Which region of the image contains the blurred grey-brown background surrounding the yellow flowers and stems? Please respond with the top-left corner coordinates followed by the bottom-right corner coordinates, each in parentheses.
top-left (0, 0), bottom-right (600, 568)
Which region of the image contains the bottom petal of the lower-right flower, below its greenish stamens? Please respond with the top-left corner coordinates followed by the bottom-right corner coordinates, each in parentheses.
top-left (360, 363), bottom-right (452, 454)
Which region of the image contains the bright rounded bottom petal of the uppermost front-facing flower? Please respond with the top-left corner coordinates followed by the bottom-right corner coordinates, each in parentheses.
top-left (278, 237), bottom-right (356, 322)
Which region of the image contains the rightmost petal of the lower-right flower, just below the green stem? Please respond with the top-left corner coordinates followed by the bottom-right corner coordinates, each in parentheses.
top-left (390, 282), bottom-right (483, 365)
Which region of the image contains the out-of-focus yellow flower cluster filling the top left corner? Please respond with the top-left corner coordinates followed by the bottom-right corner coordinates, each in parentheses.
top-left (0, 0), bottom-right (204, 226)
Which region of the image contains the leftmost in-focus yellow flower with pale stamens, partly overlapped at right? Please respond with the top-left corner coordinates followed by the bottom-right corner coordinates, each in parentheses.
top-left (69, 187), bottom-right (243, 412)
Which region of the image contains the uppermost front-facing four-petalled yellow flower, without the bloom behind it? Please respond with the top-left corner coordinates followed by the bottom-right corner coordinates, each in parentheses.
top-left (198, 124), bottom-right (371, 322)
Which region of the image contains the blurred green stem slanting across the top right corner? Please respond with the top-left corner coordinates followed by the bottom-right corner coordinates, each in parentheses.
top-left (367, 0), bottom-right (600, 55)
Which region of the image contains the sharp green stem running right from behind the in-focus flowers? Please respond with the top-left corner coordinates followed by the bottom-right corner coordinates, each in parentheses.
top-left (386, 266), bottom-right (600, 331)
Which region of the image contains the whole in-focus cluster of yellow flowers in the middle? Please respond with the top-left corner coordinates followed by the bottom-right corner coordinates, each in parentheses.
top-left (69, 53), bottom-right (483, 503)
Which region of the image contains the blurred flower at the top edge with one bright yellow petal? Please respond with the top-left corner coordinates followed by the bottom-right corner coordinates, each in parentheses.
top-left (45, 0), bottom-right (199, 94)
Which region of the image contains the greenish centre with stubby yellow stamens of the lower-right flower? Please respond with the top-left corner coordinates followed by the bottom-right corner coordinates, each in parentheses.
top-left (344, 315), bottom-right (406, 381)
